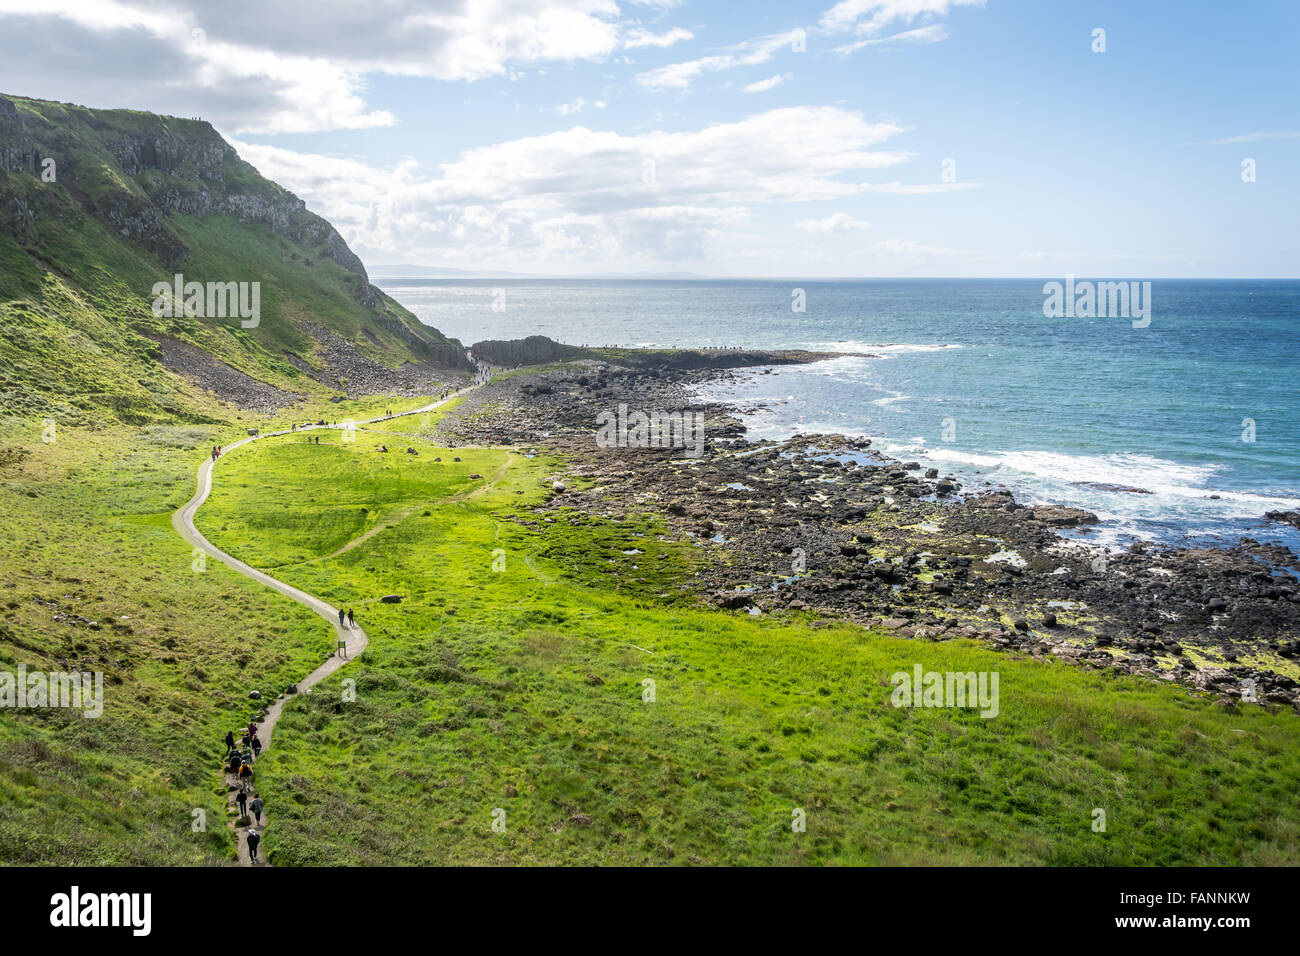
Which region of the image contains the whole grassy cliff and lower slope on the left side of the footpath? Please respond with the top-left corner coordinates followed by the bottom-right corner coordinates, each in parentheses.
top-left (0, 95), bottom-right (467, 864)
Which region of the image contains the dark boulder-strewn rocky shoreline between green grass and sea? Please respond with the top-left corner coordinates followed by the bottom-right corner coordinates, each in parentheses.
top-left (437, 356), bottom-right (1300, 710)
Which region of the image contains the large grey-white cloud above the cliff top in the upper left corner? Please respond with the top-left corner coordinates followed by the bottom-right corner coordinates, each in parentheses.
top-left (0, 0), bottom-right (690, 134)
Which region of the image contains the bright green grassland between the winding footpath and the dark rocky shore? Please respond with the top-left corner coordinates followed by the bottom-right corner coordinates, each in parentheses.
top-left (198, 436), bottom-right (1300, 865)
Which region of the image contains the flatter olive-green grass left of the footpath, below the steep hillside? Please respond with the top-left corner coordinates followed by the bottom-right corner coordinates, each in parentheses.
top-left (0, 425), bottom-right (332, 865)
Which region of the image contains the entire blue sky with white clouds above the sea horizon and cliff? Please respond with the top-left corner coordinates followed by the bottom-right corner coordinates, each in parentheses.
top-left (0, 0), bottom-right (1300, 278)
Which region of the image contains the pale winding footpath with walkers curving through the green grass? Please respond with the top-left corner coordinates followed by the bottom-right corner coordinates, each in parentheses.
top-left (172, 380), bottom-right (482, 866)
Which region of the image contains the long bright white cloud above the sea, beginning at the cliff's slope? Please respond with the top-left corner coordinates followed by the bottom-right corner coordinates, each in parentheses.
top-left (237, 107), bottom-right (928, 265)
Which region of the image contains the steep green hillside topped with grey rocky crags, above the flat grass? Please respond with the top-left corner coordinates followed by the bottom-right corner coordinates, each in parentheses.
top-left (0, 95), bottom-right (468, 420)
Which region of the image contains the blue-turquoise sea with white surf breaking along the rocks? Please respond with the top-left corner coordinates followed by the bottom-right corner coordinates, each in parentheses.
top-left (377, 277), bottom-right (1300, 550)
